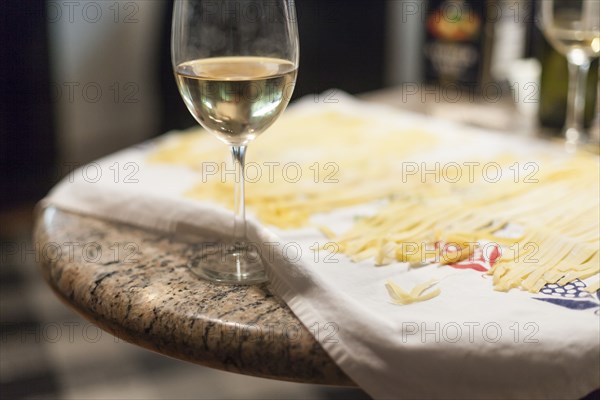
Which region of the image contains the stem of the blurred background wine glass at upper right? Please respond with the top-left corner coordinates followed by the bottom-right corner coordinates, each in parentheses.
top-left (565, 57), bottom-right (590, 143)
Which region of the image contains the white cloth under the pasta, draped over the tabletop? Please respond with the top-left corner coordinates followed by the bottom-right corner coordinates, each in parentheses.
top-left (46, 97), bottom-right (600, 399)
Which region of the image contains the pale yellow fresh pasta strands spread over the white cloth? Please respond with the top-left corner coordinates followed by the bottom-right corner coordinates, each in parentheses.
top-left (149, 108), bottom-right (600, 294)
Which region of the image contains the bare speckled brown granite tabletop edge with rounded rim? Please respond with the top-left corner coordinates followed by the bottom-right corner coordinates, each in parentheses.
top-left (35, 208), bottom-right (354, 386)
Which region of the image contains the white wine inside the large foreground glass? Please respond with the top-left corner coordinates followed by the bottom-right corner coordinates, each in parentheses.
top-left (176, 57), bottom-right (296, 144)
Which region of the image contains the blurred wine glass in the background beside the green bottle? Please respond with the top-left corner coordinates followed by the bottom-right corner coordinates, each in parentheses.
top-left (538, 0), bottom-right (600, 146)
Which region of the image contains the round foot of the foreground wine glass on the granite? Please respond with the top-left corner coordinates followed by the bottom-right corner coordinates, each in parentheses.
top-left (188, 246), bottom-right (268, 285)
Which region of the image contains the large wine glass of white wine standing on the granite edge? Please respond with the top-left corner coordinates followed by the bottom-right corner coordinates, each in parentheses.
top-left (171, 0), bottom-right (299, 284)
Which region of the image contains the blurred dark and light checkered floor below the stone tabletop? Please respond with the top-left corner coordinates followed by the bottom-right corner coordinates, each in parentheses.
top-left (0, 209), bottom-right (368, 399)
